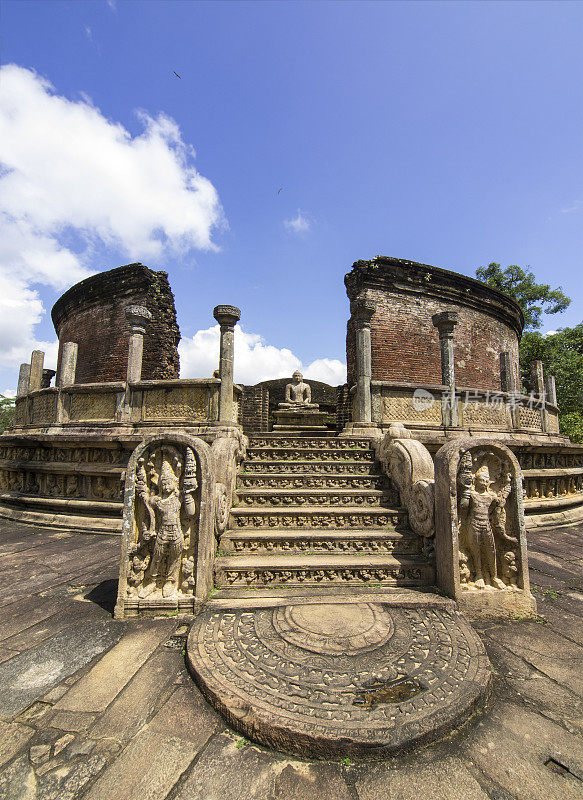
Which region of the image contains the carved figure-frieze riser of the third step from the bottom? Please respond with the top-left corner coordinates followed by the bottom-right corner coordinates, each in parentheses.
top-left (229, 508), bottom-right (407, 529)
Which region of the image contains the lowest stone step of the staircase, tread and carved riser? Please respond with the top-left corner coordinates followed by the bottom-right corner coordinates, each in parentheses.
top-left (215, 553), bottom-right (435, 588)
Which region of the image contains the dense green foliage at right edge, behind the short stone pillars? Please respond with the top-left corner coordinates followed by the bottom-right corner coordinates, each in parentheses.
top-left (520, 322), bottom-right (583, 443)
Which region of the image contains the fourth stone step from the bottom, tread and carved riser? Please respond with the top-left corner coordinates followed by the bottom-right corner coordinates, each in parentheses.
top-left (237, 489), bottom-right (395, 508)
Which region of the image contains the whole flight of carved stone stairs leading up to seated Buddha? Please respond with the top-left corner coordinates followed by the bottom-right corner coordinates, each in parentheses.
top-left (215, 434), bottom-right (435, 589)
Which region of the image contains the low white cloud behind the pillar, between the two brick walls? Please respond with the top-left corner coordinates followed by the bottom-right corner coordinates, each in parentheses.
top-left (178, 325), bottom-right (346, 386)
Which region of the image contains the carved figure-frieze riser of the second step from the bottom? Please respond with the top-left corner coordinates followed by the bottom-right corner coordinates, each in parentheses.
top-left (221, 535), bottom-right (422, 556)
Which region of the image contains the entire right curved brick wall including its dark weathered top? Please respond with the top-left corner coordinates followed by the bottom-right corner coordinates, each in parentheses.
top-left (344, 256), bottom-right (524, 390)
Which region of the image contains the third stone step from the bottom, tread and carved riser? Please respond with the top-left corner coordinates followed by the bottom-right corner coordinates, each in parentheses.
top-left (229, 506), bottom-right (407, 530)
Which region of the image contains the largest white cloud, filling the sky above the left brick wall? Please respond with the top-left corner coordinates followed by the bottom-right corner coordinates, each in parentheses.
top-left (0, 65), bottom-right (225, 367)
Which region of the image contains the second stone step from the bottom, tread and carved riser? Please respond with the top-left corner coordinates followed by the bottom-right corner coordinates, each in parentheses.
top-left (220, 526), bottom-right (423, 555)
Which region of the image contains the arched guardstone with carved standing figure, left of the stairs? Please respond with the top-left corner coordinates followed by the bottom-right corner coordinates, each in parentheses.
top-left (116, 434), bottom-right (214, 617)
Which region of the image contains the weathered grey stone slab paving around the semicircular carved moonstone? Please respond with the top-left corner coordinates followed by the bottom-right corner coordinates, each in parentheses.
top-left (0, 522), bottom-right (583, 800)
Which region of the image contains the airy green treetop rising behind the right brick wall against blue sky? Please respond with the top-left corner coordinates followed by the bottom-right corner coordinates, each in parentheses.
top-left (476, 261), bottom-right (571, 330)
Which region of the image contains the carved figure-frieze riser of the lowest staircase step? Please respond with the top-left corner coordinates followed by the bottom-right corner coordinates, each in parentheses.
top-left (215, 565), bottom-right (435, 588)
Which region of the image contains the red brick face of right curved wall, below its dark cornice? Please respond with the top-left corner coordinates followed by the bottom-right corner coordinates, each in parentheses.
top-left (346, 258), bottom-right (519, 390)
